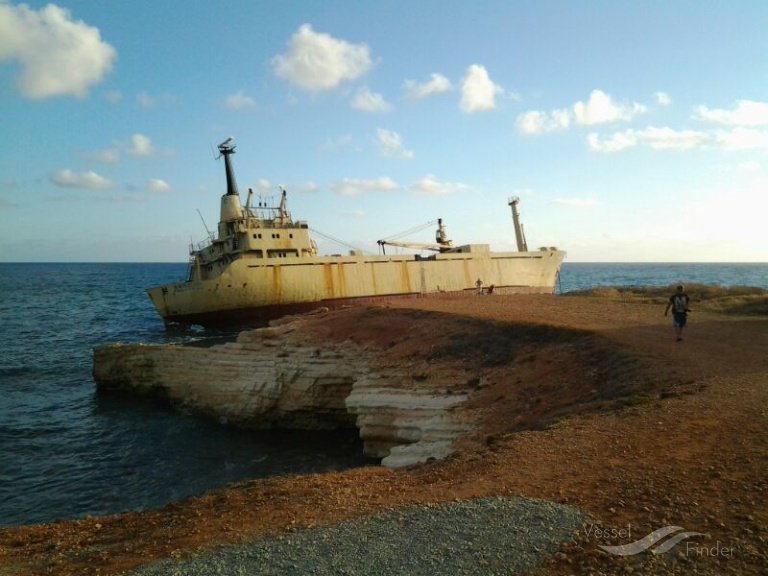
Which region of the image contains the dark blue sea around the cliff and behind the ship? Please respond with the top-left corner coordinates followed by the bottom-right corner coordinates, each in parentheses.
top-left (0, 263), bottom-right (768, 527)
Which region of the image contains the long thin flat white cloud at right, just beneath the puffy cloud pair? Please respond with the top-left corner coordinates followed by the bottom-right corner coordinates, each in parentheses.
top-left (587, 126), bottom-right (711, 152)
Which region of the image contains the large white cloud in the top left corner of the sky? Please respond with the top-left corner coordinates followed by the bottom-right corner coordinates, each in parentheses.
top-left (0, 2), bottom-right (117, 99)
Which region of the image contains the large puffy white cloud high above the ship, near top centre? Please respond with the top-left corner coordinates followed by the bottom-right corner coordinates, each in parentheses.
top-left (272, 24), bottom-right (372, 91)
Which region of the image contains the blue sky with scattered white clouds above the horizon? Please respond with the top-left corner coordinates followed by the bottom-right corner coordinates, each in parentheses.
top-left (0, 0), bottom-right (768, 262)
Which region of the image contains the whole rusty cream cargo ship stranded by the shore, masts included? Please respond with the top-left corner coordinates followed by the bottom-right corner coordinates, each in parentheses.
top-left (147, 138), bottom-right (565, 327)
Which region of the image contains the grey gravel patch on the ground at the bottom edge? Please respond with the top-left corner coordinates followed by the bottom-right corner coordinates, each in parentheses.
top-left (125, 498), bottom-right (589, 576)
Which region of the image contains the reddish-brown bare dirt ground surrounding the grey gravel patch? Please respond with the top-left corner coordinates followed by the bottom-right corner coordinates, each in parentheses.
top-left (0, 296), bottom-right (768, 575)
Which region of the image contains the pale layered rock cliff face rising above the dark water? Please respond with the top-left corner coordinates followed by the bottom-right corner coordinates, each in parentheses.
top-left (93, 318), bottom-right (470, 468)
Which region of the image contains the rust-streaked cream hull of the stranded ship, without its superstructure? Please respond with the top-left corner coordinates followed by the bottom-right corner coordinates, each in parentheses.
top-left (148, 250), bottom-right (565, 327)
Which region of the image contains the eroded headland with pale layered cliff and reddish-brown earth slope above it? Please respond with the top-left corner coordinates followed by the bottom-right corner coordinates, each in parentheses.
top-left (94, 299), bottom-right (656, 467)
